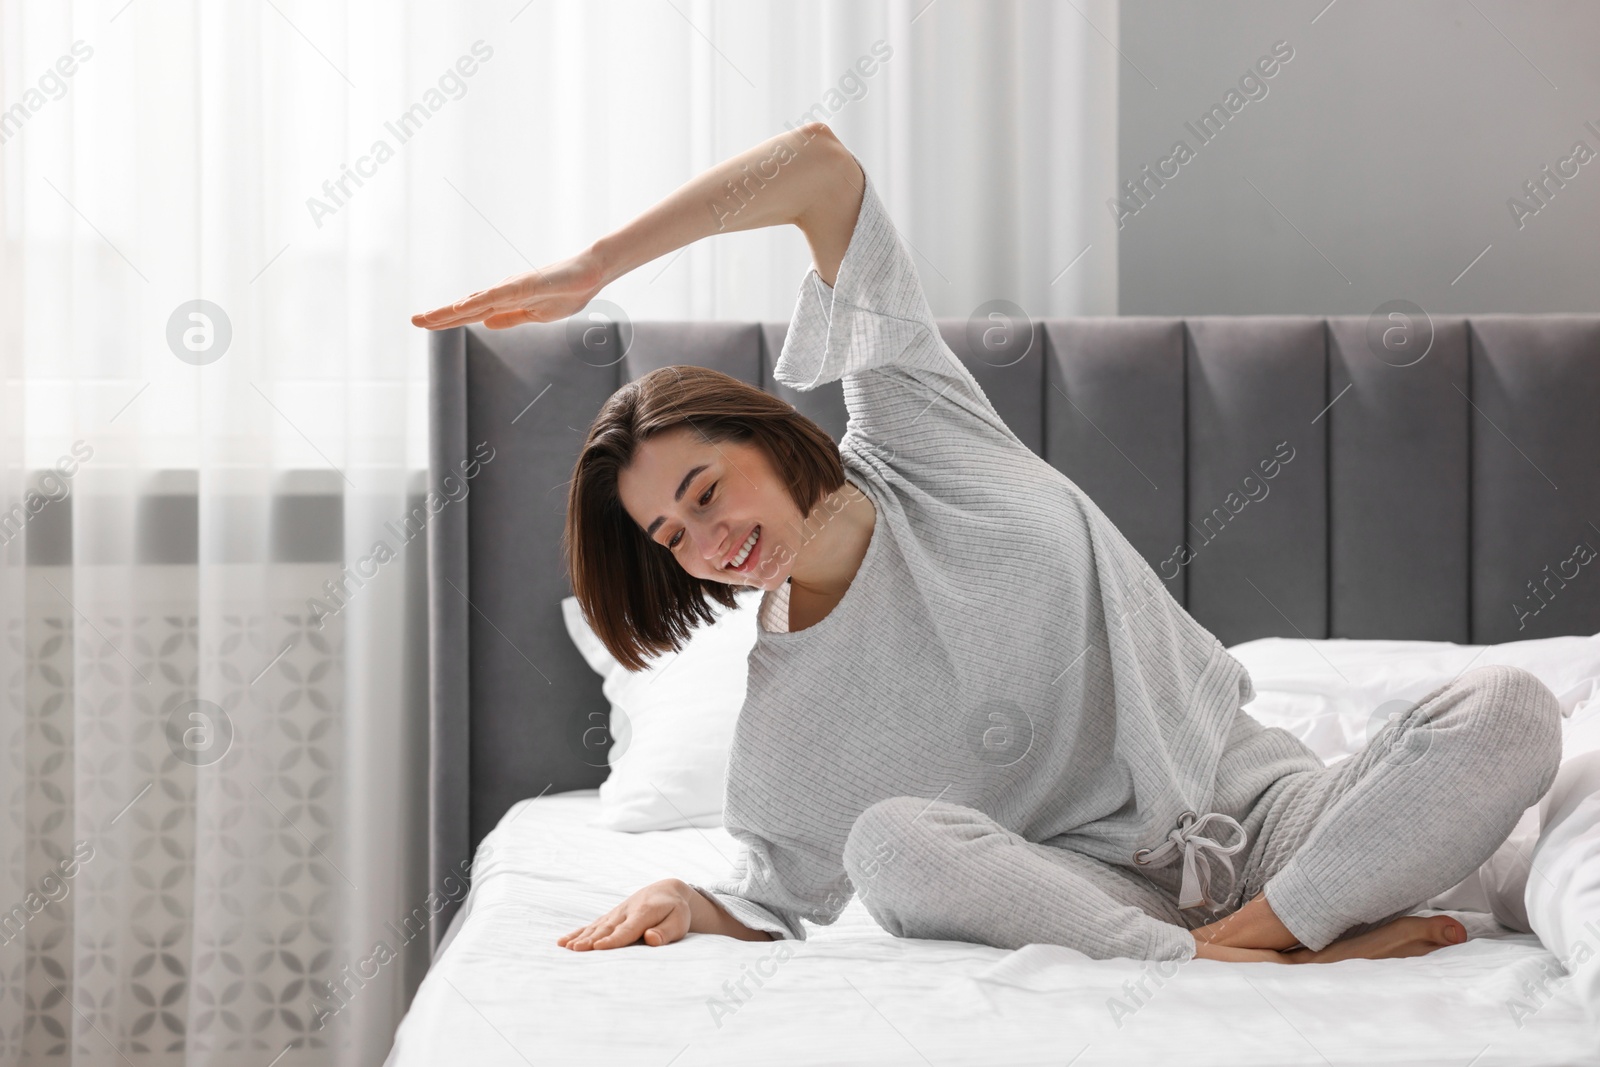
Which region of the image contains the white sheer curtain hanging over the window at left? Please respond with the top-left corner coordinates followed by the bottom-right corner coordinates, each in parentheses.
top-left (0, 0), bottom-right (1118, 1067)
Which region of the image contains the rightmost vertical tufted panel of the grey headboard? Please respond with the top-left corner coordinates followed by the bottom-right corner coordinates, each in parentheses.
top-left (1469, 315), bottom-right (1600, 645)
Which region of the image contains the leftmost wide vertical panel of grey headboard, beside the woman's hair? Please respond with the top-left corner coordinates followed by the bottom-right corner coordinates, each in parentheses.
top-left (464, 323), bottom-right (619, 845)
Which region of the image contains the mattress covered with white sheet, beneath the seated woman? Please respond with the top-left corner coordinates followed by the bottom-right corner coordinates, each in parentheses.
top-left (387, 790), bottom-right (1600, 1067)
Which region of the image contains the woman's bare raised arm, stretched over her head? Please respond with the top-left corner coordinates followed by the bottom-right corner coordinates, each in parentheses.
top-left (411, 122), bottom-right (864, 330)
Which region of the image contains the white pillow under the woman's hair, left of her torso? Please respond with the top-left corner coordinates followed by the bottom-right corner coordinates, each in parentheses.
top-left (562, 589), bottom-right (762, 832)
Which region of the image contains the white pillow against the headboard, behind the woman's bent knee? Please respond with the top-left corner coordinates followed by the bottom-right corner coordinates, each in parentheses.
top-left (1227, 633), bottom-right (1600, 765)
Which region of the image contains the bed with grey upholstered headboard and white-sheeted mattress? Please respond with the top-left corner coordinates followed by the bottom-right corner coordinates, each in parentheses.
top-left (389, 315), bottom-right (1600, 1067)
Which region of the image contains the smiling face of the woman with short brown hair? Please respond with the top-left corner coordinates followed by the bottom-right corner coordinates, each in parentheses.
top-left (618, 427), bottom-right (805, 589)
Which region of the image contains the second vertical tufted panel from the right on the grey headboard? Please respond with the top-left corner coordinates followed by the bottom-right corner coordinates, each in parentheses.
top-left (1323, 315), bottom-right (1470, 643)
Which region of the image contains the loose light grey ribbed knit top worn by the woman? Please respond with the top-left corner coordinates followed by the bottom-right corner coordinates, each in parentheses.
top-left (681, 163), bottom-right (1322, 960)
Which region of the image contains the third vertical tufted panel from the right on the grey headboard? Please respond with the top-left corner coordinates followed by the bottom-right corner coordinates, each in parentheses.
top-left (1184, 315), bottom-right (1328, 645)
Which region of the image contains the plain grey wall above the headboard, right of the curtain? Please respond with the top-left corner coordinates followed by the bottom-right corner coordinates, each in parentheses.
top-left (1107, 0), bottom-right (1600, 315)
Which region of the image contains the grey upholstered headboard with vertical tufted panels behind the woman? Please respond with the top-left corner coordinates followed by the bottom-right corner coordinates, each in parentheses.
top-left (429, 315), bottom-right (1600, 929)
